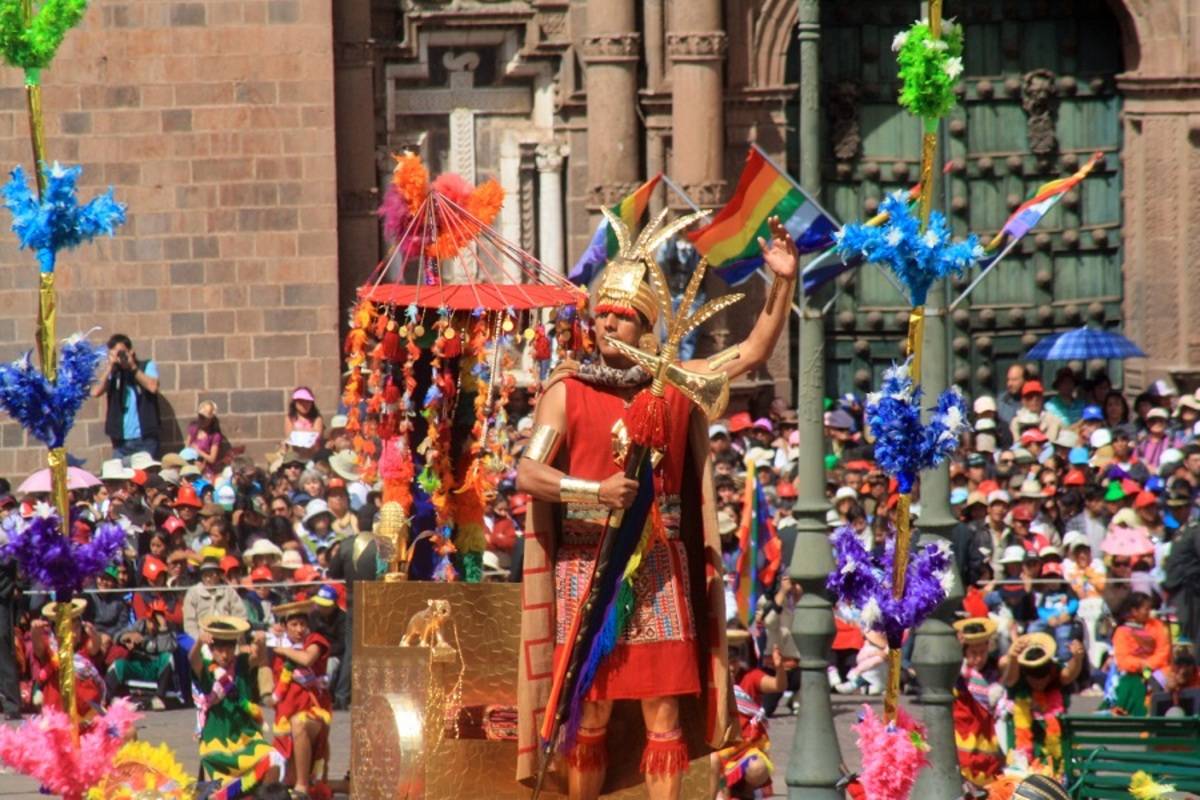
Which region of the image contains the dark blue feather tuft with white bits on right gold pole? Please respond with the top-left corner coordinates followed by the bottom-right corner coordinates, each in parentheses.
top-left (866, 361), bottom-right (967, 494)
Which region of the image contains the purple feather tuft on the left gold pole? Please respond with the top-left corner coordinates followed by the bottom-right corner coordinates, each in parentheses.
top-left (2, 506), bottom-right (125, 595)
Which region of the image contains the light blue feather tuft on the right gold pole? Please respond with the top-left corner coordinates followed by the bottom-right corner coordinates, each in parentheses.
top-left (835, 192), bottom-right (984, 307)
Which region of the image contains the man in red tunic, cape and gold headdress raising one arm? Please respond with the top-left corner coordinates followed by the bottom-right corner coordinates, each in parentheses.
top-left (517, 209), bottom-right (797, 800)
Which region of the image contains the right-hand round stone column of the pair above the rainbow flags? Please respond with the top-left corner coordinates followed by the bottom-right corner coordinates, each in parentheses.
top-left (667, 0), bottom-right (727, 207)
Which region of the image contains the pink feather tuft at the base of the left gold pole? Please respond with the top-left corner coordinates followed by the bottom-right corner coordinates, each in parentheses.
top-left (0, 699), bottom-right (140, 800)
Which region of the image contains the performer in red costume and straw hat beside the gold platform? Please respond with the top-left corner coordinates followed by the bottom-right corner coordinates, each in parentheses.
top-left (271, 600), bottom-right (334, 793)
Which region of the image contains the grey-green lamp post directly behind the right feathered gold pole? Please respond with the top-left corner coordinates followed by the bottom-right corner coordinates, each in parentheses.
top-left (912, 273), bottom-right (962, 798)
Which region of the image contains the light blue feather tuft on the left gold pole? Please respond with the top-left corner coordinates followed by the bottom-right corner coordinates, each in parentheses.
top-left (2, 162), bottom-right (125, 272)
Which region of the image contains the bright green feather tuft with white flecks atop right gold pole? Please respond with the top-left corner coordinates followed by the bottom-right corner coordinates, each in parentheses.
top-left (892, 20), bottom-right (962, 128)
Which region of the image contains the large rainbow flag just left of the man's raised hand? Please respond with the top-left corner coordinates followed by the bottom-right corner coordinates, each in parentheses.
top-left (688, 148), bottom-right (838, 285)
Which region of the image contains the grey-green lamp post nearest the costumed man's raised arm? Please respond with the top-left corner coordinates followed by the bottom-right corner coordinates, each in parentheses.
top-left (787, 0), bottom-right (842, 800)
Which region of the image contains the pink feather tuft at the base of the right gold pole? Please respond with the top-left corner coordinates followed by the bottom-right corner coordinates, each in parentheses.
top-left (851, 705), bottom-right (929, 800)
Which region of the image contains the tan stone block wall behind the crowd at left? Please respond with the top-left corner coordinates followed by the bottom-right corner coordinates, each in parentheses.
top-left (0, 0), bottom-right (340, 482)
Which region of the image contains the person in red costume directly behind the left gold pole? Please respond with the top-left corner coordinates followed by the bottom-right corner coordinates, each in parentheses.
top-left (30, 597), bottom-right (107, 730)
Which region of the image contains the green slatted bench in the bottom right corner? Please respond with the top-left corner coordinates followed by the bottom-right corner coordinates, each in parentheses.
top-left (1062, 715), bottom-right (1200, 800)
